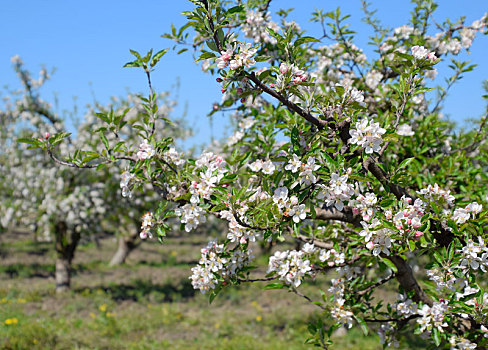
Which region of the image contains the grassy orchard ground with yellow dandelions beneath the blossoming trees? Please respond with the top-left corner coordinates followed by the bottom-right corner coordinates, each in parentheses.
top-left (0, 233), bottom-right (423, 350)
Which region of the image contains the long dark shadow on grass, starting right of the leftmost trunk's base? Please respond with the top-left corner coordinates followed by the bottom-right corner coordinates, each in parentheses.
top-left (74, 279), bottom-right (195, 302)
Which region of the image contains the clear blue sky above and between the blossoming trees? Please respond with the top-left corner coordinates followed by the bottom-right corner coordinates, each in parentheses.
top-left (0, 0), bottom-right (488, 148)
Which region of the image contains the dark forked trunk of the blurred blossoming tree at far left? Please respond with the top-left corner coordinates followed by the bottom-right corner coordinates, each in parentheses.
top-left (55, 222), bottom-right (80, 293)
